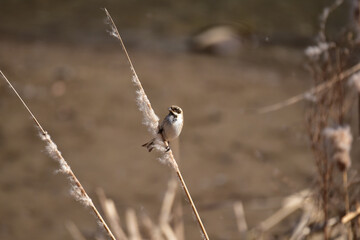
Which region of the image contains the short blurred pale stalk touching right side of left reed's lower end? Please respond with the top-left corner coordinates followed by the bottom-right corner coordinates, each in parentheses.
top-left (96, 188), bottom-right (128, 240)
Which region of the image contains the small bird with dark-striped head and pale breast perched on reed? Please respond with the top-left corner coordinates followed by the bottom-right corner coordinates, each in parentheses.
top-left (142, 105), bottom-right (184, 152)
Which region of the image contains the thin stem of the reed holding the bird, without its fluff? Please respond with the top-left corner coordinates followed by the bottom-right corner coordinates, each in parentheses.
top-left (104, 8), bottom-right (209, 240)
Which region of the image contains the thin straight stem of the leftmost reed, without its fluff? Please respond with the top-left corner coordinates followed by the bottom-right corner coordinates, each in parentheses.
top-left (0, 71), bottom-right (116, 240)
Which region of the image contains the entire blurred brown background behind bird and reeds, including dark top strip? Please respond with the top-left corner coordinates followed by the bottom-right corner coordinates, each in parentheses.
top-left (0, 0), bottom-right (356, 240)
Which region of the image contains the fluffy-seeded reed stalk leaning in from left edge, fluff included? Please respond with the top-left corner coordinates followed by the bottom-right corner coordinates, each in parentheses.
top-left (0, 71), bottom-right (116, 240)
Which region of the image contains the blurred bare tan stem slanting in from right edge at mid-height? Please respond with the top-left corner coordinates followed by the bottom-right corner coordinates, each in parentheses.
top-left (255, 63), bottom-right (360, 114)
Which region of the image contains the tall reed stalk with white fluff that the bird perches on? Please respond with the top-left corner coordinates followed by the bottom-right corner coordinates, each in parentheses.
top-left (104, 9), bottom-right (209, 240)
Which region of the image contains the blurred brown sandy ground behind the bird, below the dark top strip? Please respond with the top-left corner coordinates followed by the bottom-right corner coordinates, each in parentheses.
top-left (0, 39), bottom-right (315, 240)
